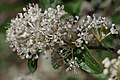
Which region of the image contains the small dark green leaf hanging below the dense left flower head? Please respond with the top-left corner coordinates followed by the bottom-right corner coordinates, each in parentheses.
top-left (28, 59), bottom-right (38, 73)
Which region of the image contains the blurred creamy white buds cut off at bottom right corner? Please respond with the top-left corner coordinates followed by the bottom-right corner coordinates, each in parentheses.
top-left (102, 56), bottom-right (120, 80)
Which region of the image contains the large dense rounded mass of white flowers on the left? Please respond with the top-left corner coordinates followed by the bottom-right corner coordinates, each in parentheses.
top-left (6, 4), bottom-right (65, 59)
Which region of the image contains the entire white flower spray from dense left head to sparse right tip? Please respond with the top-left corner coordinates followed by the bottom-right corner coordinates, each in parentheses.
top-left (6, 4), bottom-right (118, 69)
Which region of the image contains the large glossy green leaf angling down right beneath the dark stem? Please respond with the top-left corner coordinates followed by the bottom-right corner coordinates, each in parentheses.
top-left (81, 46), bottom-right (102, 74)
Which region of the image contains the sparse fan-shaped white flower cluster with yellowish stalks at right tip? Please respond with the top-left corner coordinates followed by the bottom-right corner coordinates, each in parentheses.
top-left (82, 15), bottom-right (118, 41)
